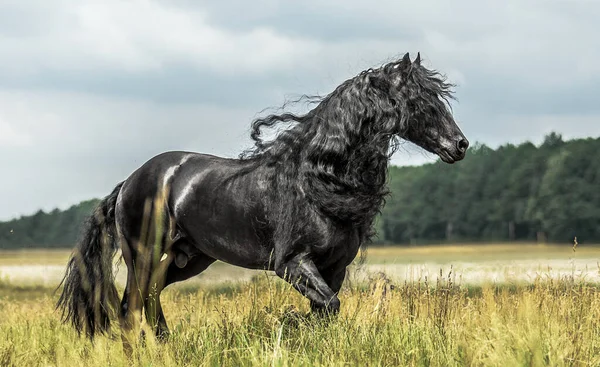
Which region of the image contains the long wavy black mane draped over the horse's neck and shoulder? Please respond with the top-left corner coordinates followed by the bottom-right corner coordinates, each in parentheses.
top-left (240, 60), bottom-right (452, 246)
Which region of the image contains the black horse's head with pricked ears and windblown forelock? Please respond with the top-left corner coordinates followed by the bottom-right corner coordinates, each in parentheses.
top-left (372, 53), bottom-right (469, 163)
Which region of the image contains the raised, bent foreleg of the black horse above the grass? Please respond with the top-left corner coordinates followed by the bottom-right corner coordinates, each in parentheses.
top-left (275, 254), bottom-right (340, 314)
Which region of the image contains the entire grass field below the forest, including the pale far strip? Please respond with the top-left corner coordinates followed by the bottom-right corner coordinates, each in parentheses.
top-left (0, 244), bottom-right (600, 367)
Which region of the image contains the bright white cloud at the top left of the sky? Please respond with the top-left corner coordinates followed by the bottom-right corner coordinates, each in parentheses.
top-left (0, 0), bottom-right (320, 75)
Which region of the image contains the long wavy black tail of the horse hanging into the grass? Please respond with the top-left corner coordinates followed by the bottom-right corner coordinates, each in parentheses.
top-left (56, 182), bottom-right (123, 340)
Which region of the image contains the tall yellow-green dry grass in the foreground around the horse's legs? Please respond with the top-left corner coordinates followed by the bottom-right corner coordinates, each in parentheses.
top-left (0, 273), bottom-right (600, 367)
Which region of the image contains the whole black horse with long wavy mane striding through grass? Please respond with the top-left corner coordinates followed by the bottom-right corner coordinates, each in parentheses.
top-left (57, 53), bottom-right (469, 343)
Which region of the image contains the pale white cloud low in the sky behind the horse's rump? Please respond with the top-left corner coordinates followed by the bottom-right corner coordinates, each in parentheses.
top-left (0, 90), bottom-right (252, 220)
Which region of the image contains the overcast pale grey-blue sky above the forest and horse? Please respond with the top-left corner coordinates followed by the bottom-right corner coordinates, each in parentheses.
top-left (0, 0), bottom-right (600, 220)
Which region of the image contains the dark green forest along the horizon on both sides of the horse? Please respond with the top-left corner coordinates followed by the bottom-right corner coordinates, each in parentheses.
top-left (0, 133), bottom-right (600, 248)
